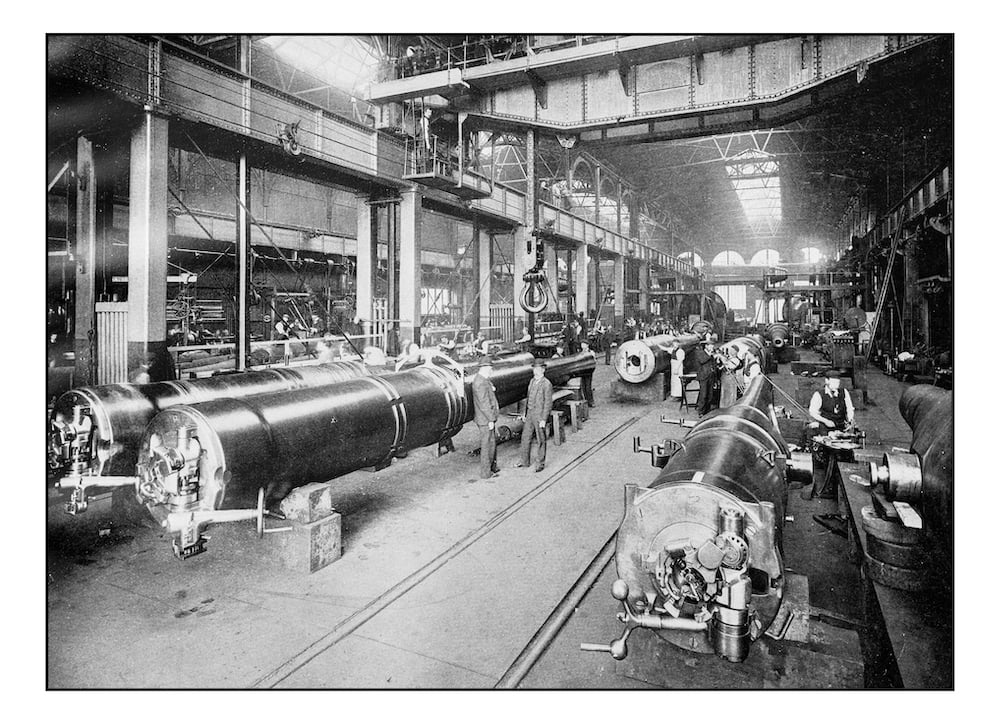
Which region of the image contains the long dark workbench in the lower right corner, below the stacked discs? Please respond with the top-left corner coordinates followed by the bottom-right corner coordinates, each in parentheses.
top-left (837, 462), bottom-right (954, 689)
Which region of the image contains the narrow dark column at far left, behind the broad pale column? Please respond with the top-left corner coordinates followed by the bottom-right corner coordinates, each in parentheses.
top-left (73, 136), bottom-right (97, 385)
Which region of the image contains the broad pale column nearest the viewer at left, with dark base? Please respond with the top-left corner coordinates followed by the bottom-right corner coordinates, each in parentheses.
top-left (128, 111), bottom-right (173, 380)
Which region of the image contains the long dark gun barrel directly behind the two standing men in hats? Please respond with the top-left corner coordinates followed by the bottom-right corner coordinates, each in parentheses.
top-left (129, 354), bottom-right (595, 558)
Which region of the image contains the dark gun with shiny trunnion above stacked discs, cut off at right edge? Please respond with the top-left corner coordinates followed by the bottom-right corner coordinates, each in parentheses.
top-left (863, 385), bottom-right (955, 590)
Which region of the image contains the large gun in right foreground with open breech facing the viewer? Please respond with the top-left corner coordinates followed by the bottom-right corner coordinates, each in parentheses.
top-left (586, 376), bottom-right (809, 662)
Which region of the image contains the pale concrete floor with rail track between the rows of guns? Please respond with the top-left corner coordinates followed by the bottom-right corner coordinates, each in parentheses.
top-left (47, 354), bottom-right (909, 689)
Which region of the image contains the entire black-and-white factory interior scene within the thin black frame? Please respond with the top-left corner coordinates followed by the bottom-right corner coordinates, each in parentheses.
top-left (27, 18), bottom-right (996, 717)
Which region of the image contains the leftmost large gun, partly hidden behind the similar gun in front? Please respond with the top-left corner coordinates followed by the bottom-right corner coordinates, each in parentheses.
top-left (48, 361), bottom-right (369, 514)
